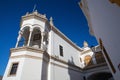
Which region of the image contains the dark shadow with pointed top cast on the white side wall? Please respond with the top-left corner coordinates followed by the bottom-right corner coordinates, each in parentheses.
top-left (68, 57), bottom-right (83, 80)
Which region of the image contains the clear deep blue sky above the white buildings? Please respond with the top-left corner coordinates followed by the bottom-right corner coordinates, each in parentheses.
top-left (0, 0), bottom-right (97, 75)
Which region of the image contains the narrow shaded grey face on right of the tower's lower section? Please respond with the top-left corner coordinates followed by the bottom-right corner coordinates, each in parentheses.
top-left (41, 52), bottom-right (50, 80)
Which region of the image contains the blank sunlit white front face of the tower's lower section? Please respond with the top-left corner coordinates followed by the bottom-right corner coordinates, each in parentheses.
top-left (21, 58), bottom-right (42, 80)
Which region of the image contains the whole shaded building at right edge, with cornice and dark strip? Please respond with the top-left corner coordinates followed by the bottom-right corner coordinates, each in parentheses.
top-left (79, 0), bottom-right (120, 80)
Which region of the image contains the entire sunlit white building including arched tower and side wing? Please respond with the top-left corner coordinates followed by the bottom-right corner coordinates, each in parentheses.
top-left (3, 11), bottom-right (113, 80)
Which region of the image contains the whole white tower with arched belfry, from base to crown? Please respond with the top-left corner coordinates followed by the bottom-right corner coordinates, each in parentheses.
top-left (3, 10), bottom-right (49, 80)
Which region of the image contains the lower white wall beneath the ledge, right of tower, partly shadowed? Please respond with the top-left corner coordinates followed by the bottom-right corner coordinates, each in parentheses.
top-left (50, 63), bottom-right (83, 80)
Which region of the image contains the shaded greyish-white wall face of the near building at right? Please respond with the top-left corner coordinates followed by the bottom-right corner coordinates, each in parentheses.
top-left (80, 0), bottom-right (120, 80)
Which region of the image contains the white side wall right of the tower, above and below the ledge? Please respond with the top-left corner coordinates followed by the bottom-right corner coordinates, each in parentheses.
top-left (48, 30), bottom-right (83, 80)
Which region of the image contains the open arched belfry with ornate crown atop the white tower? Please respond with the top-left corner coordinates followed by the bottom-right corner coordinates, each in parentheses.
top-left (15, 10), bottom-right (48, 49)
